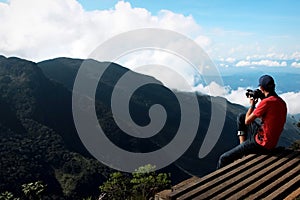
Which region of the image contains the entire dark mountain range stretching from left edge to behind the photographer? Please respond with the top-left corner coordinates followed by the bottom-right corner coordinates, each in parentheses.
top-left (0, 56), bottom-right (299, 199)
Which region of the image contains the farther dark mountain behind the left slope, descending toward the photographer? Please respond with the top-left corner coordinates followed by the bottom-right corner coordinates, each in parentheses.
top-left (38, 58), bottom-right (300, 176)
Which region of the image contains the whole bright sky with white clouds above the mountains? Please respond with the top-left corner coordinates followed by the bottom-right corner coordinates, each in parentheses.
top-left (0, 0), bottom-right (300, 113)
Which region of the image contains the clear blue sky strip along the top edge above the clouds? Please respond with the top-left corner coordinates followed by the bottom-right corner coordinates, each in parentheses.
top-left (79, 0), bottom-right (300, 36)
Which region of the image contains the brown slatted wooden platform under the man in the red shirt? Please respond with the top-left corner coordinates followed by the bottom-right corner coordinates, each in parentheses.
top-left (155, 149), bottom-right (300, 200)
